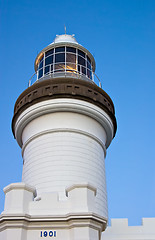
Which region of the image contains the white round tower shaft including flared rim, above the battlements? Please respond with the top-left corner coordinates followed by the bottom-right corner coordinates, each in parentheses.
top-left (15, 99), bottom-right (113, 218)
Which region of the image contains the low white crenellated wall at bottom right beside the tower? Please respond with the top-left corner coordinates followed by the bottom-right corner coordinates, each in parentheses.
top-left (102, 218), bottom-right (155, 240)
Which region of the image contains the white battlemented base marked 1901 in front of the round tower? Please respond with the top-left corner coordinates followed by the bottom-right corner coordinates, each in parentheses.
top-left (0, 183), bottom-right (107, 240)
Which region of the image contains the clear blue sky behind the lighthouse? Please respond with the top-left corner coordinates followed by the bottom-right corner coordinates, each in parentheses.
top-left (0, 0), bottom-right (155, 225)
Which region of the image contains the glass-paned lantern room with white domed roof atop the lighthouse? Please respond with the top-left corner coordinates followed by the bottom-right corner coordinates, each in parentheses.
top-left (35, 34), bottom-right (95, 81)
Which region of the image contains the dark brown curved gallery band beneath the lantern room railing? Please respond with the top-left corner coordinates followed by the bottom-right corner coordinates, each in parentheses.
top-left (12, 78), bottom-right (117, 140)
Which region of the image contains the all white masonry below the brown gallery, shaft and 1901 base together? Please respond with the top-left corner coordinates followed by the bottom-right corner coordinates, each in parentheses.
top-left (0, 98), bottom-right (114, 240)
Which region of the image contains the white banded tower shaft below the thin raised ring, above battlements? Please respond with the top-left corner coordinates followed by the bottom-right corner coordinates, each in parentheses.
top-left (23, 128), bottom-right (107, 216)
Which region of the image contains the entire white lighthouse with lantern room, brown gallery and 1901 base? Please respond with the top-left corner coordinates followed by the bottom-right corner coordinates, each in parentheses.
top-left (0, 34), bottom-right (116, 240)
